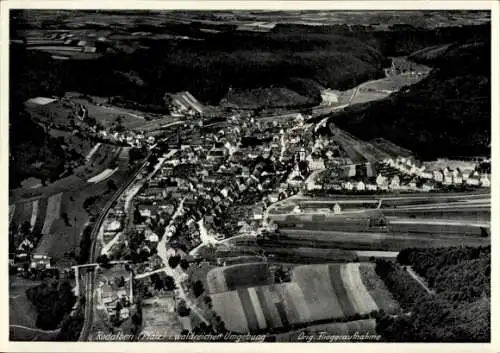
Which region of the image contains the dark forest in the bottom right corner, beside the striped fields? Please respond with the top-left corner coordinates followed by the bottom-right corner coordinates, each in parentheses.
top-left (375, 247), bottom-right (491, 342)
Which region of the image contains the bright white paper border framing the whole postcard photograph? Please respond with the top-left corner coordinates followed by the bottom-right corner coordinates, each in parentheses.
top-left (0, 0), bottom-right (500, 353)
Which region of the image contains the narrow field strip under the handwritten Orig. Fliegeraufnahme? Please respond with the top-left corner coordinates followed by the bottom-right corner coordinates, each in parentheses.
top-left (275, 319), bottom-right (376, 343)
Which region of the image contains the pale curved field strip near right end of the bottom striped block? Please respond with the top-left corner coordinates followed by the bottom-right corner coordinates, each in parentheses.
top-left (341, 263), bottom-right (378, 314)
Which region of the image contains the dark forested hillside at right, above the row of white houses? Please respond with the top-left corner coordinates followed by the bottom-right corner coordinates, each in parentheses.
top-left (332, 33), bottom-right (491, 159)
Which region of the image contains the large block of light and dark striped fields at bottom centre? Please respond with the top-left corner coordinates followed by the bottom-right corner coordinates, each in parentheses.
top-left (212, 263), bottom-right (396, 332)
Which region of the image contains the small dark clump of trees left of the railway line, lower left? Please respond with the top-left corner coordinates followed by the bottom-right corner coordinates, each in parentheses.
top-left (26, 281), bottom-right (76, 330)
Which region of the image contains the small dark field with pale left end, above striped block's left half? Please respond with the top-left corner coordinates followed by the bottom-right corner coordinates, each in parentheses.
top-left (207, 262), bottom-right (271, 293)
